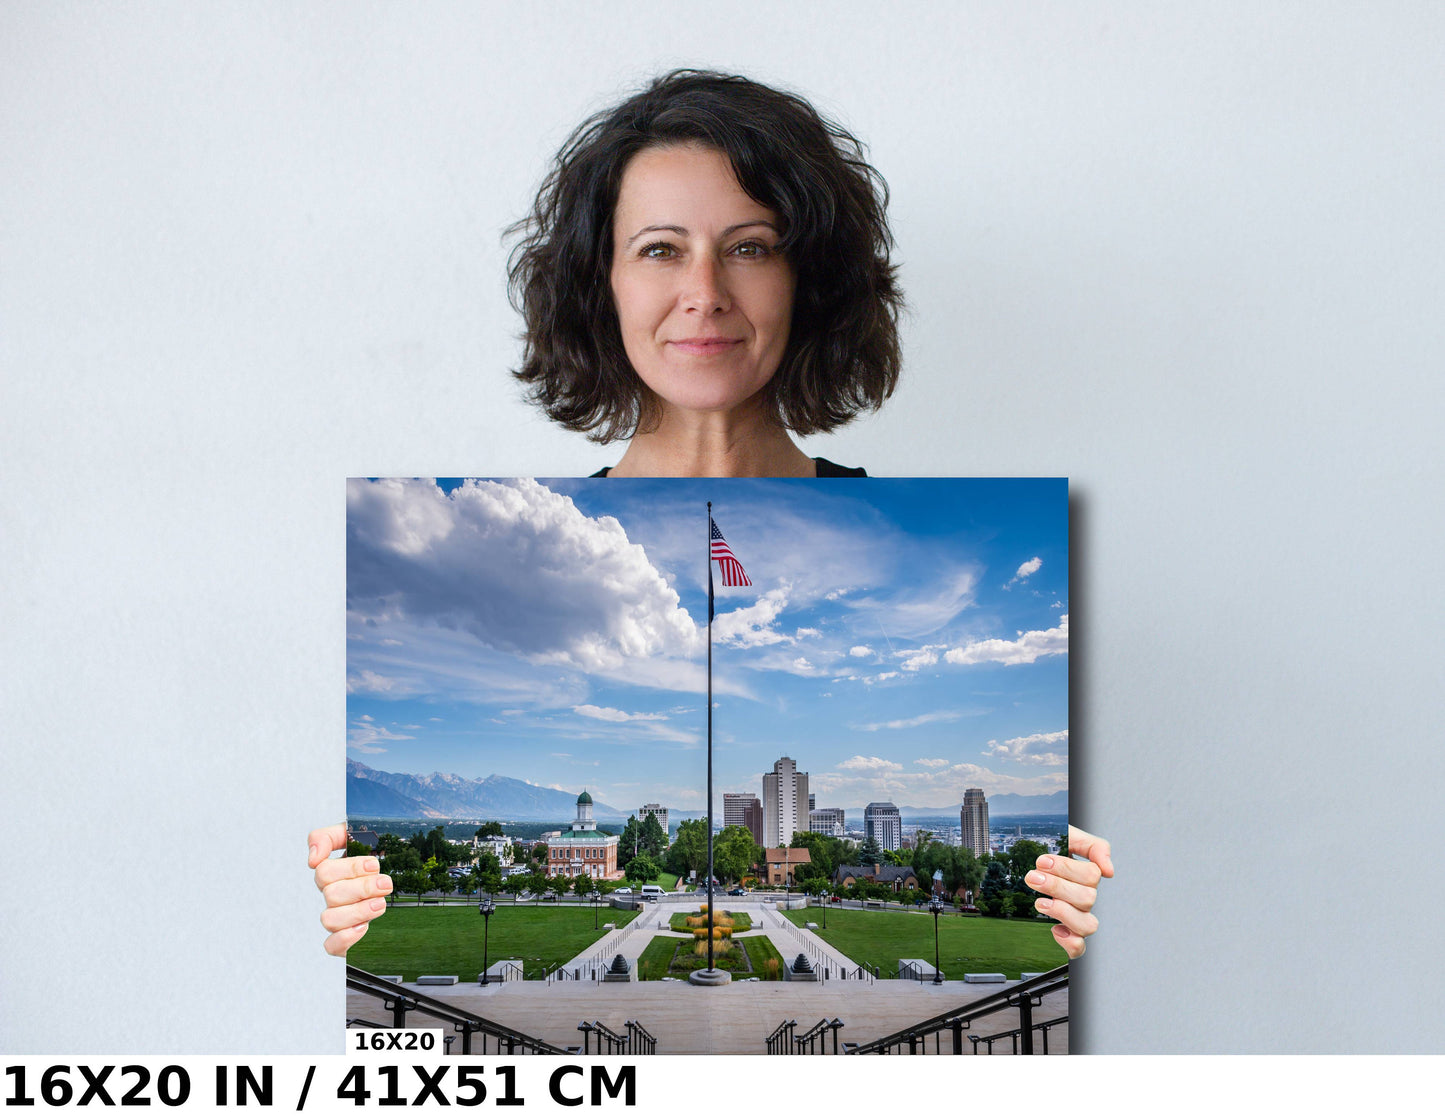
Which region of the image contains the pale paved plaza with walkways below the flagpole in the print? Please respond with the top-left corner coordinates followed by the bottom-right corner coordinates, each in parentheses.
top-left (347, 896), bottom-right (1068, 1055)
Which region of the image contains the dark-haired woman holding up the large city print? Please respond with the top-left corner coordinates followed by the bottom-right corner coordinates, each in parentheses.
top-left (308, 71), bottom-right (1113, 958)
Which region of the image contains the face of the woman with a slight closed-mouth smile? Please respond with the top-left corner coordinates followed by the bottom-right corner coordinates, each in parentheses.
top-left (611, 145), bottom-right (795, 412)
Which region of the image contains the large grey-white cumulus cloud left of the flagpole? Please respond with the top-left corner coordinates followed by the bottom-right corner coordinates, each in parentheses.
top-left (347, 478), bottom-right (698, 670)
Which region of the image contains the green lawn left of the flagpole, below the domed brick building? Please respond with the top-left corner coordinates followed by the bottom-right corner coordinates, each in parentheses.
top-left (347, 905), bottom-right (637, 981)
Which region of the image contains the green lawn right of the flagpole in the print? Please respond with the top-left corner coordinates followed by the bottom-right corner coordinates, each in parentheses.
top-left (786, 907), bottom-right (1068, 980)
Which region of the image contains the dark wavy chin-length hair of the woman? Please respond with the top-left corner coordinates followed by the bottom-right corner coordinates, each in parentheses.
top-left (507, 69), bottom-right (903, 442)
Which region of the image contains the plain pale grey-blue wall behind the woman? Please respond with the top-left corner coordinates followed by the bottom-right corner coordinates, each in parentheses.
top-left (0, 3), bottom-right (1445, 1053)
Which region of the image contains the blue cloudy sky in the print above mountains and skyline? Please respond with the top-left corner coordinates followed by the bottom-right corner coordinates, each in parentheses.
top-left (347, 478), bottom-right (1068, 811)
